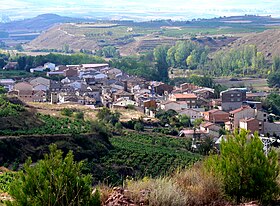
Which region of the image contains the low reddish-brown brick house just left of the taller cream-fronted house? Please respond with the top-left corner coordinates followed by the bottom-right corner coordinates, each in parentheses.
top-left (202, 109), bottom-right (229, 123)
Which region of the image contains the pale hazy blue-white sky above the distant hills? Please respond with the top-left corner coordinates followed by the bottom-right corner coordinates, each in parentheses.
top-left (0, 0), bottom-right (280, 20)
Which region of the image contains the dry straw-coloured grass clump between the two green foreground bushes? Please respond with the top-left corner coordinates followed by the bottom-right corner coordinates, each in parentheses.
top-left (120, 166), bottom-right (229, 206)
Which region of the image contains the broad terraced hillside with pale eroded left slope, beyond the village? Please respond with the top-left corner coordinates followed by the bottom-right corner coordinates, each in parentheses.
top-left (25, 23), bottom-right (237, 56)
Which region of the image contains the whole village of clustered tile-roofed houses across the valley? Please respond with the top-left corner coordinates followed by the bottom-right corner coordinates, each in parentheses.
top-left (0, 63), bottom-right (280, 146)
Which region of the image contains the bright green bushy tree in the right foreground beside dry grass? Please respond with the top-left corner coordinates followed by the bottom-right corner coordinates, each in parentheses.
top-left (206, 130), bottom-right (279, 203)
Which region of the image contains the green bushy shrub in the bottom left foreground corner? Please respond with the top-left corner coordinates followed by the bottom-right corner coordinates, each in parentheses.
top-left (8, 145), bottom-right (101, 206)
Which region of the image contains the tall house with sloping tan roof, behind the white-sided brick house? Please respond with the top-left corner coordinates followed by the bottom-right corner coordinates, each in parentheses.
top-left (225, 106), bottom-right (256, 131)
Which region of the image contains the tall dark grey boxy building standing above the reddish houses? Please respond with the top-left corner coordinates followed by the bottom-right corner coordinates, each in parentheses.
top-left (220, 88), bottom-right (247, 111)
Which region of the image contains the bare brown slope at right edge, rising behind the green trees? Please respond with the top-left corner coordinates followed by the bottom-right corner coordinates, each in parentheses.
top-left (227, 29), bottom-right (280, 59)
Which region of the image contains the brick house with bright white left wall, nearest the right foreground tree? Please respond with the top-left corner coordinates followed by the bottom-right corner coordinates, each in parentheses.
top-left (239, 118), bottom-right (263, 134)
